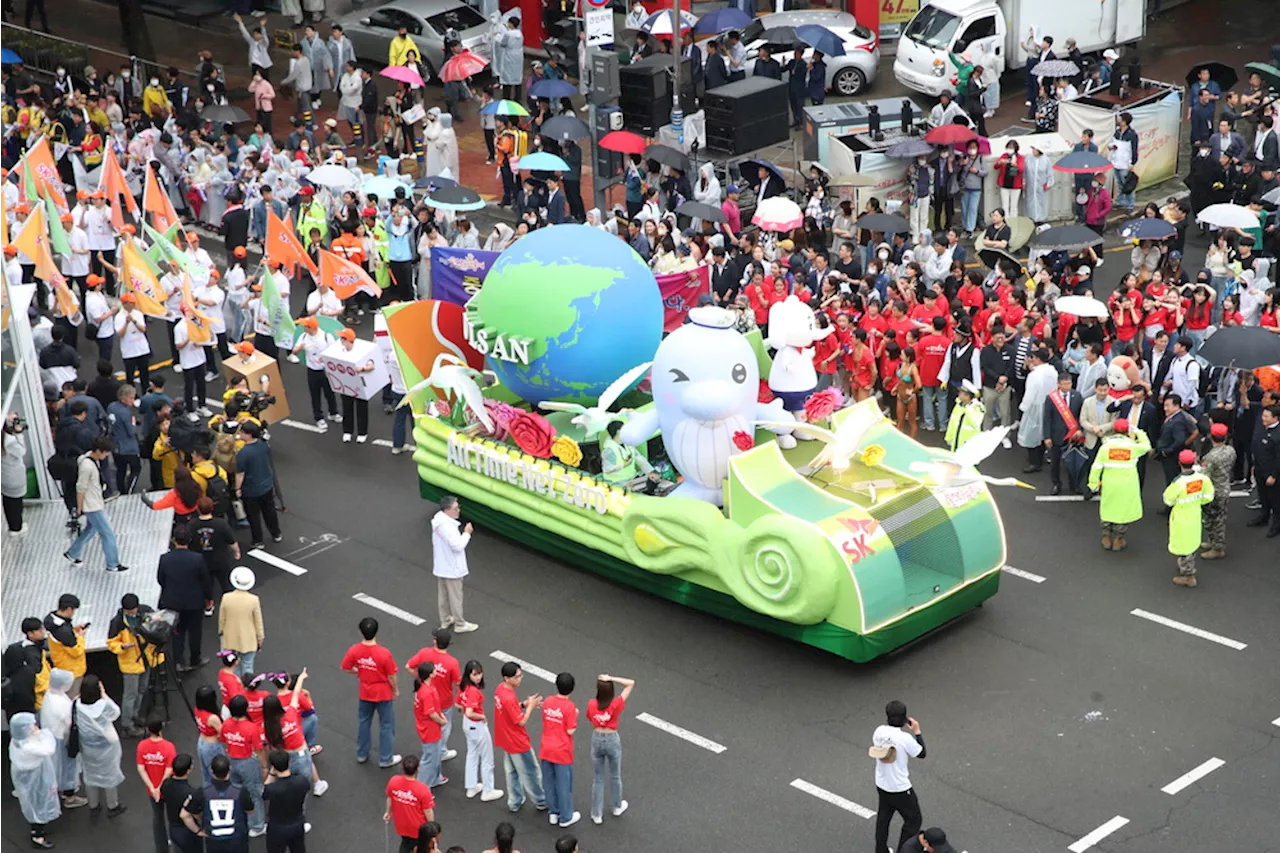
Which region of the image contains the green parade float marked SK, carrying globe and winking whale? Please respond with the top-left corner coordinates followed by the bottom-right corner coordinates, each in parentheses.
top-left (385, 225), bottom-right (1005, 662)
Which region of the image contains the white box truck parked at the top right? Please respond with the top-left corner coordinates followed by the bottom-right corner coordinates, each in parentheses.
top-left (893, 0), bottom-right (1147, 97)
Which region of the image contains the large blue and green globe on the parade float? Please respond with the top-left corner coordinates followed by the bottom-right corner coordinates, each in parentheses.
top-left (467, 224), bottom-right (663, 403)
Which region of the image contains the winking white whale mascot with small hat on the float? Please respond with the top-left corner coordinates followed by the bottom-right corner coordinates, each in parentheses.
top-left (618, 306), bottom-right (795, 506)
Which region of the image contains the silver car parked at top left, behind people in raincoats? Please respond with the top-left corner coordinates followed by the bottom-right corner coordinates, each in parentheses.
top-left (338, 0), bottom-right (493, 77)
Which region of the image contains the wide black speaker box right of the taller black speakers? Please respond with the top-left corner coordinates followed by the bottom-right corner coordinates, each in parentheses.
top-left (703, 77), bottom-right (791, 154)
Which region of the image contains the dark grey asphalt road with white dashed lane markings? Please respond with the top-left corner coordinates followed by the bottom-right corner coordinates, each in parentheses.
top-left (0, 224), bottom-right (1280, 853)
